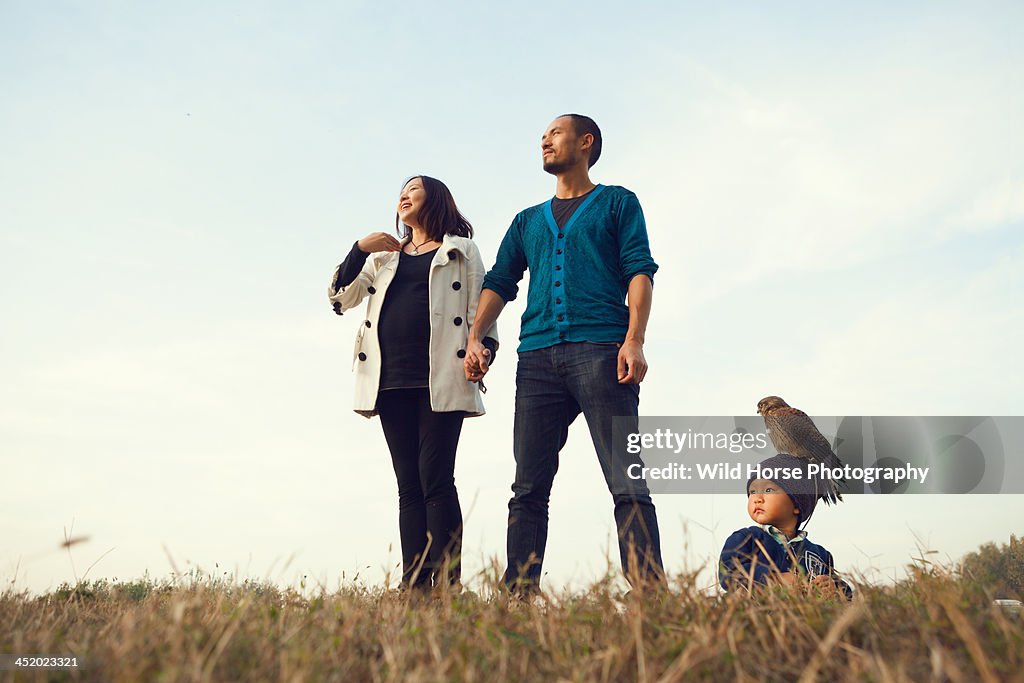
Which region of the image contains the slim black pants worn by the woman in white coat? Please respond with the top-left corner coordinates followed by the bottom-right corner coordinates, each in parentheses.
top-left (377, 388), bottom-right (465, 588)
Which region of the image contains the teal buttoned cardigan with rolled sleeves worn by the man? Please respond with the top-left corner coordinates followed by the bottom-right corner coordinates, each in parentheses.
top-left (483, 185), bottom-right (657, 352)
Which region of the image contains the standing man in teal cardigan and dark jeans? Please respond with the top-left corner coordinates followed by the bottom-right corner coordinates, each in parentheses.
top-left (465, 114), bottom-right (664, 595)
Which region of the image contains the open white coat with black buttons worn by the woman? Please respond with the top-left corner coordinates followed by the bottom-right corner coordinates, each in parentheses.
top-left (328, 234), bottom-right (498, 418)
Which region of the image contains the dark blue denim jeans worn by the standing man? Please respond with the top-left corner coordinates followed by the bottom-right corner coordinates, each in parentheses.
top-left (505, 342), bottom-right (664, 591)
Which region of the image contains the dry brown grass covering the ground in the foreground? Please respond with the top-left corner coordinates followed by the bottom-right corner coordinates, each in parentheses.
top-left (0, 566), bottom-right (1024, 683)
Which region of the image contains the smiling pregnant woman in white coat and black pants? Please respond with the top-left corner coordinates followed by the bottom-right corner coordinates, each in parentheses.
top-left (328, 175), bottom-right (498, 589)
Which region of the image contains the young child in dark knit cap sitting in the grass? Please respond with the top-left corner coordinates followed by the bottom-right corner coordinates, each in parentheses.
top-left (719, 454), bottom-right (853, 600)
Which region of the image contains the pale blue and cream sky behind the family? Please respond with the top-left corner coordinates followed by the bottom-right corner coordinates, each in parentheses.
top-left (0, 0), bottom-right (1024, 591)
